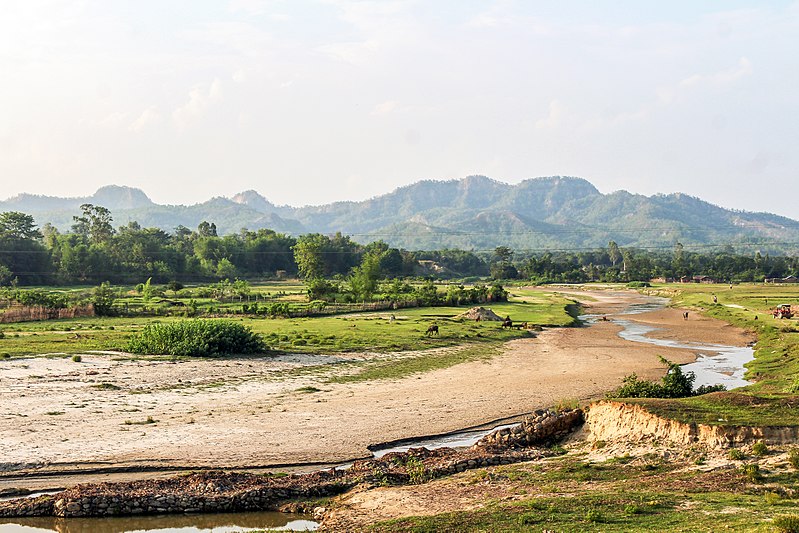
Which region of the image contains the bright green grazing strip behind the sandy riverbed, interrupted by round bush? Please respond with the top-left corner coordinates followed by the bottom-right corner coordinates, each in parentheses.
top-left (0, 286), bottom-right (575, 358)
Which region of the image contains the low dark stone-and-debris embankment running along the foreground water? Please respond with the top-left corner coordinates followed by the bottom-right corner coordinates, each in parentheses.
top-left (0, 410), bottom-right (583, 517)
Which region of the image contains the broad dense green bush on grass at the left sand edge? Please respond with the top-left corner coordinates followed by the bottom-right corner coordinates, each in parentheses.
top-left (126, 320), bottom-right (268, 357)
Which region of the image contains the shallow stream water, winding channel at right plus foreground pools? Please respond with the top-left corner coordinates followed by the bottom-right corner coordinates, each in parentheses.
top-left (0, 297), bottom-right (754, 533)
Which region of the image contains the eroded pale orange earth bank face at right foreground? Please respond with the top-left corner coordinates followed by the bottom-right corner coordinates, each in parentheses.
top-left (585, 401), bottom-right (799, 448)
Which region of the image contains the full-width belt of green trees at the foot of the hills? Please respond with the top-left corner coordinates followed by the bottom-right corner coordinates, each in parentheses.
top-left (0, 204), bottom-right (799, 288)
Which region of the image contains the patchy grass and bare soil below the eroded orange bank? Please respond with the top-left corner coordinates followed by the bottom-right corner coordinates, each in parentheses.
top-left (367, 455), bottom-right (799, 533)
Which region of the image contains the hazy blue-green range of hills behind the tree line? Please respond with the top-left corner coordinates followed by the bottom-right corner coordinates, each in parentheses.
top-left (6, 176), bottom-right (799, 253)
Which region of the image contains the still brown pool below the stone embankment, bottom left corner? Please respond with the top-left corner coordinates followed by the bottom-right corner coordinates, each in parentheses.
top-left (0, 512), bottom-right (319, 533)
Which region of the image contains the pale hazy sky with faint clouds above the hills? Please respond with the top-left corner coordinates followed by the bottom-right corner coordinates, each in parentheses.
top-left (0, 0), bottom-right (799, 219)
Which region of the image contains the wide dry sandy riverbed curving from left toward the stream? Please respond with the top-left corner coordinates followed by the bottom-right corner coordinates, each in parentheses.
top-left (0, 292), bottom-right (749, 489)
